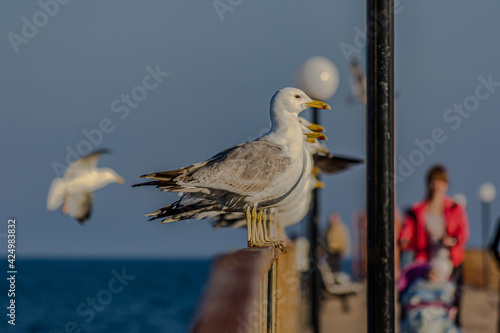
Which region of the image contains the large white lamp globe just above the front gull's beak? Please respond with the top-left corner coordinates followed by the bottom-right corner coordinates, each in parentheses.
top-left (295, 57), bottom-right (339, 101)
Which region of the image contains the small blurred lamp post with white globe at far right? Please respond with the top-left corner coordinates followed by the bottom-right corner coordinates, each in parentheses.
top-left (478, 183), bottom-right (497, 289)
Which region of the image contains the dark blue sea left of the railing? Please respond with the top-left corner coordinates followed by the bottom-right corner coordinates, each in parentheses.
top-left (0, 260), bottom-right (211, 333)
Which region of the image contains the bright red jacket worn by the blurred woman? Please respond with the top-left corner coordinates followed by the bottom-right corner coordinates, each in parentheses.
top-left (398, 197), bottom-right (469, 267)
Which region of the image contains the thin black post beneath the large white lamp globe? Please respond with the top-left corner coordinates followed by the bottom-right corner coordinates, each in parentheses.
top-left (308, 108), bottom-right (321, 333)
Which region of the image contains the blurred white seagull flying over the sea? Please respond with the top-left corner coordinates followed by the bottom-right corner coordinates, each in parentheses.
top-left (47, 150), bottom-right (124, 224)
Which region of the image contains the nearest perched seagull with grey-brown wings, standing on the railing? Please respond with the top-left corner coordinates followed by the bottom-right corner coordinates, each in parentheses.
top-left (133, 88), bottom-right (330, 246)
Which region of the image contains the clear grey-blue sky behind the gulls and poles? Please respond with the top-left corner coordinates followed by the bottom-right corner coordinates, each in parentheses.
top-left (0, 0), bottom-right (500, 258)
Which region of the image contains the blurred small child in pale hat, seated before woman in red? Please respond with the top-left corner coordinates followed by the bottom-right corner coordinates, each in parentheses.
top-left (401, 256), bottom-right (458, 333)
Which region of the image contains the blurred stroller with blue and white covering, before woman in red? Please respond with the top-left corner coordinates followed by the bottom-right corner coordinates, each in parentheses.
top-left (397, 259), bottom-right (459, 333)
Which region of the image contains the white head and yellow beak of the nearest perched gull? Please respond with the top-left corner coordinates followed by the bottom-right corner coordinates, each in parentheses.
top-left (271, 87), bottom-right (331, 115)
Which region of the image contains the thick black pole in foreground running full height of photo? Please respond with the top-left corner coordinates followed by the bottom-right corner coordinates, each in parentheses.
top-left (366, 0), bottom-right (395, 333)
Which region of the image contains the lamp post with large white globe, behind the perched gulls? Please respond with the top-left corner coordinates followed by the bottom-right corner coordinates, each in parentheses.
top-left (296, 57), bottom-right (339, 333)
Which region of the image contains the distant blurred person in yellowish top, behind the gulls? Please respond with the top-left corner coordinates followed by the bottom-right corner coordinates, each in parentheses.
top-left (326, 213), bottom-right (350, 273)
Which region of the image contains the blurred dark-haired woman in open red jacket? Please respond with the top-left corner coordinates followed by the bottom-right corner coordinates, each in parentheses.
top-left (398, 165), bottom-right (469, 326)
